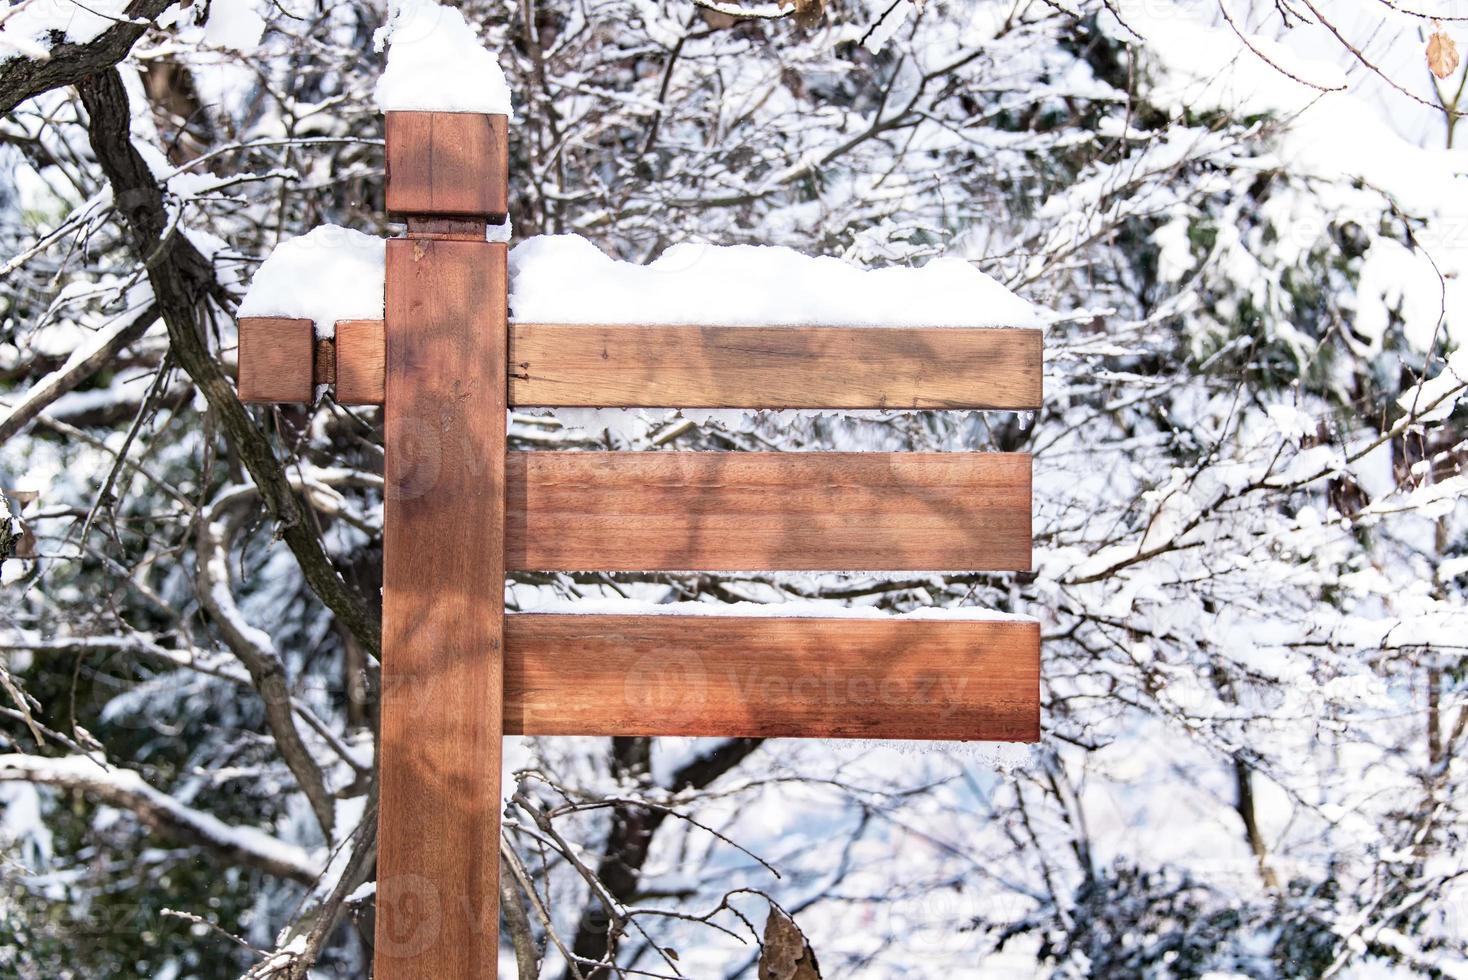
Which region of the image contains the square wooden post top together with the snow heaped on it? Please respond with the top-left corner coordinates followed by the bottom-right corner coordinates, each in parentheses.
top-left (376, 0), bottom-right (511, 224)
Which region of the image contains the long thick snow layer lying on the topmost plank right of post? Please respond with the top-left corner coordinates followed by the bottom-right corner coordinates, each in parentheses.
top-left (509, 235), bottom-right (1044, 327)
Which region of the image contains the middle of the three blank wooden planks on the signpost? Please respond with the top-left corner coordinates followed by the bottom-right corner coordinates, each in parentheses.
top-left (504, 454), bottom-right (1031, 571)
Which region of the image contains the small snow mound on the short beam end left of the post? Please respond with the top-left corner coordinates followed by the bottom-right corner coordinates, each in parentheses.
top-left (238, 224), bottom-right (388, 337)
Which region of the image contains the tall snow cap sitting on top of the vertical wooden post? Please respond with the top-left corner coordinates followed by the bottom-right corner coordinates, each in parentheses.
top-left (374, 0), bottom-right (514, 116)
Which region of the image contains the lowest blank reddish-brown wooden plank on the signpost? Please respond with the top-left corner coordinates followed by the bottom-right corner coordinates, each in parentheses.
top-left (505, 613), bottom-right (1039, 742)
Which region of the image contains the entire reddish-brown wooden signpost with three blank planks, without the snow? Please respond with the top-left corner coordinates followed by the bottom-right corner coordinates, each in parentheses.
top-left (239, 113), bottom-right (1041, 980)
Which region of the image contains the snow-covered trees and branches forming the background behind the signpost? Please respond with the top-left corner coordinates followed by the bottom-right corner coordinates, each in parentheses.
top-left (0, 0), bottom-right (1468, 980)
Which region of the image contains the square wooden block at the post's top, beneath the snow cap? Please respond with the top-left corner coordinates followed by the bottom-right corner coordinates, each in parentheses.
top-left (386, 111), bottom-right (509, 218)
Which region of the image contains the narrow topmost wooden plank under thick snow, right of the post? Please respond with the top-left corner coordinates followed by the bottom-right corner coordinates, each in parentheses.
top-left (509, 323), bottom-right (1044, 409)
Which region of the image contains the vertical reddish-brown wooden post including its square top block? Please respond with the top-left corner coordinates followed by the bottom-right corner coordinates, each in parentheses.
top-left (376, 113), bottom-right (506, 980)
